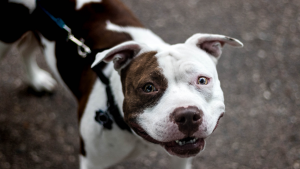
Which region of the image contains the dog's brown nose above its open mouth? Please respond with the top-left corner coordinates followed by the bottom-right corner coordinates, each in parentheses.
top-left (171, 106), bottom-right (203, 136)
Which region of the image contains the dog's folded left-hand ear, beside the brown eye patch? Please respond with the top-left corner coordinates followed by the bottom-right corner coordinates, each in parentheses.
top-left (92, 41), bottom-right (142, 71)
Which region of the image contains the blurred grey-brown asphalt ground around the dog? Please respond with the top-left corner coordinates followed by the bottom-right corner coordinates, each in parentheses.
top-left (0, 0), bottom-right (300, 169)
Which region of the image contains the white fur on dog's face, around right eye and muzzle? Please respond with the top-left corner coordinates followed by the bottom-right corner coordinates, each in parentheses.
top-left (138, 44), bottom-right (225, 142)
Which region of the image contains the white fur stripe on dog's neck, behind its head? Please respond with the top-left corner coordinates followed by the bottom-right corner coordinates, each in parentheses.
top-left (106, 21), bottom-right (170, 51)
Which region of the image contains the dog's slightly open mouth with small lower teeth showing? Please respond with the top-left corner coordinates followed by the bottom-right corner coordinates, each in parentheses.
top-left (161, 137), bottom-right (205, 158)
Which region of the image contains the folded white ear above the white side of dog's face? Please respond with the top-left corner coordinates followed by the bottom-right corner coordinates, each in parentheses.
top-left (185, 33), bottom-right (244, 61)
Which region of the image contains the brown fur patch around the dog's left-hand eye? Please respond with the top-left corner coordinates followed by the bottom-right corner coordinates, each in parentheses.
top-left (121, 52), bottom-right (168, 123)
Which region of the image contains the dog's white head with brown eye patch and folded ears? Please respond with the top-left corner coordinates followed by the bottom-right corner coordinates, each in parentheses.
top-left (93, 34), bottom-right (243, 157)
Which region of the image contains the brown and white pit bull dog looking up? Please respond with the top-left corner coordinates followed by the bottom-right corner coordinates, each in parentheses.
top-left (0, 0), bottom-right (243, 169)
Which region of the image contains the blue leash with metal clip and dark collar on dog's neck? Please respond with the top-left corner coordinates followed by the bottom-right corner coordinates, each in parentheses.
top-left (36, 0), bottom-right (131, 133)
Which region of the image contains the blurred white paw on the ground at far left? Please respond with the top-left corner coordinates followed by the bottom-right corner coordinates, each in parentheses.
top-left (28, 69), bottom-right (57, 92)
